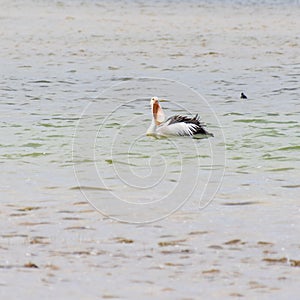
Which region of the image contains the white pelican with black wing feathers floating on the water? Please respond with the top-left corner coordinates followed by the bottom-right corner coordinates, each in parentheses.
top-left (147, 97), bottom-right (213, 136)
